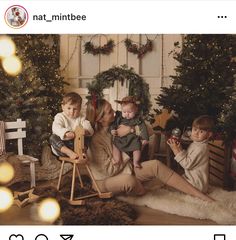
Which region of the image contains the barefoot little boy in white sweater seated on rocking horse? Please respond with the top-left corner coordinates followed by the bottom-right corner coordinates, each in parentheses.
top-left (49, 92), bottom-right (94, 159)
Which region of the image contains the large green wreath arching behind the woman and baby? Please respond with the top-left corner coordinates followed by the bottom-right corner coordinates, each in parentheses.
top-left (87, 65), bottom-right (151, 117)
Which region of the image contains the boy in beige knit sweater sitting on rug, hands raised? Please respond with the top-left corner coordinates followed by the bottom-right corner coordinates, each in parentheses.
top-left (167, 115), bottom-right (214, 193)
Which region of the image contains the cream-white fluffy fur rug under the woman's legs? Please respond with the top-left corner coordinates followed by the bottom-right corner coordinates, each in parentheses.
top-left (118, 186), bottom-right (236, 225)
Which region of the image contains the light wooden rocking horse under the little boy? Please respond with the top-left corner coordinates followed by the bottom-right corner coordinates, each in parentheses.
top-left (57, 127), bottom-right (112, 205)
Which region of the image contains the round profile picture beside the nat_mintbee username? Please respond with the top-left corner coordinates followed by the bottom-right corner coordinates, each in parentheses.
top-left (5, 5), bottom-right (28, 29)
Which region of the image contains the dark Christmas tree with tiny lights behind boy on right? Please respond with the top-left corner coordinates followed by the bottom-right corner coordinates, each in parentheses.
top-left (156, 35), bottom-right (236, 142)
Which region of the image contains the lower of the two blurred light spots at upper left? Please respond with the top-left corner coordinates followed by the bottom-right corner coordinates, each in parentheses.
top-left (2, 56), bottom-right (22, 76)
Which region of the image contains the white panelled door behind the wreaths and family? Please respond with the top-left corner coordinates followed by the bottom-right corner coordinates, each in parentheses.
top-left (60, 34), bottom-right (181, 114)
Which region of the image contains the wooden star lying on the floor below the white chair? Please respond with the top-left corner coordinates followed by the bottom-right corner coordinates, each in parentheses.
top-left (14, 188), bottom-right (39, 208)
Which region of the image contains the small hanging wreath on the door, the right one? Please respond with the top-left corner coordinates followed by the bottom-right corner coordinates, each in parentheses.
top-left (125, 38), bottom-right (153, 58)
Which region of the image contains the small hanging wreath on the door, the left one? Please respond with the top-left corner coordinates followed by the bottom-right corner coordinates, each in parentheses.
top-left (84, 39), bottom-right (115, 55)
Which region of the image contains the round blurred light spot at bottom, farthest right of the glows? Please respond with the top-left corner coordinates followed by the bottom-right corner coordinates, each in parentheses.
top-left (38, 198), bottom-right (60, 222)
